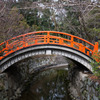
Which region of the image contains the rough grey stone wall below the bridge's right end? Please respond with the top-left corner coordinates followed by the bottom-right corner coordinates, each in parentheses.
top-left (69, 68), bottom-right (100, 100)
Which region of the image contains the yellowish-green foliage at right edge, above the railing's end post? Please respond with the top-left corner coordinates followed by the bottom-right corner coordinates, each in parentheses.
top-left (85, 7), bottom-right (100, 40)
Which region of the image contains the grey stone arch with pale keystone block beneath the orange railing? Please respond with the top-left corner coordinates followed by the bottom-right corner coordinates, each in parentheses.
top-left (0, 44), bottom-right (92, 72)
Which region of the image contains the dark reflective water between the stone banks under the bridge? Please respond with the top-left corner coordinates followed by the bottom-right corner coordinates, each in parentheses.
top-left (18, 69), bottom-right (72, 100)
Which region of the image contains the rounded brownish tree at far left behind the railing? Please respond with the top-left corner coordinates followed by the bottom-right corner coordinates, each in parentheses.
top-left (0, 7), bottom-right (30, 42)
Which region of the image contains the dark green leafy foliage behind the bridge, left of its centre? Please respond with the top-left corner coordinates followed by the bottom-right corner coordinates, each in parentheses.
top-left (20, 9), bottom-right (53, 31)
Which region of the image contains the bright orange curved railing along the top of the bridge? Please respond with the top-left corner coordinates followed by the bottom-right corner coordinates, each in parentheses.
top-left (0, 31), bottom-right (98, 60)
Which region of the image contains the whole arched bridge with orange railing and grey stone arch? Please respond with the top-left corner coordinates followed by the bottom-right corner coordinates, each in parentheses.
top-left (0, 31), bottom-right (98, 72)
